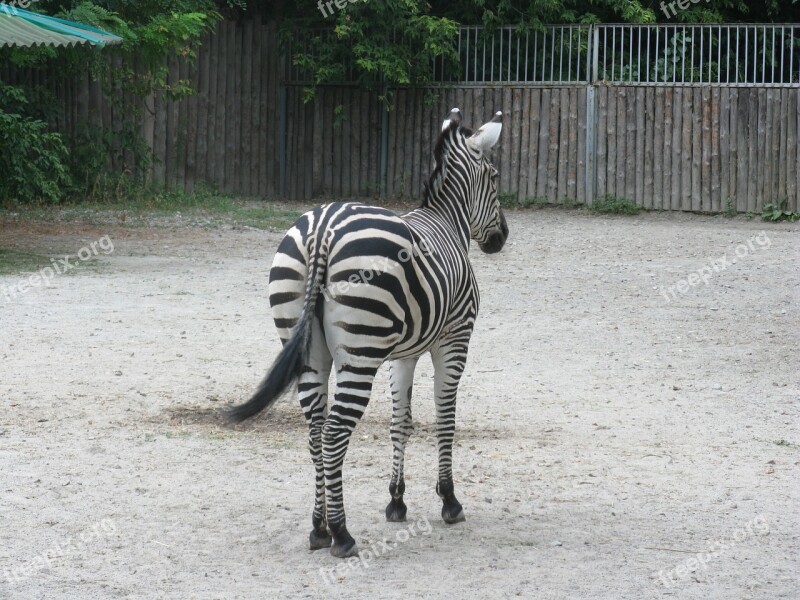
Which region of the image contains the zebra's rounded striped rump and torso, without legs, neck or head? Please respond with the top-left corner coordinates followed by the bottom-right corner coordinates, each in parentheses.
top-left (269, 203), bottom-right (472, 358)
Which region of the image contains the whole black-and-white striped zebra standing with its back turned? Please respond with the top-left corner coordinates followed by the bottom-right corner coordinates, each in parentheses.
top-left (228, 108), bottom-right (508, 558)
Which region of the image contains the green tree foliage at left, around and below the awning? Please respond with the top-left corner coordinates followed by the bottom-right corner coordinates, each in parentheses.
top-left (0, 0), bottom-right (227, 202)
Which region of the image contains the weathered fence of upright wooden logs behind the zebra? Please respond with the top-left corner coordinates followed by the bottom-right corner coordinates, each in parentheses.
top-left (0, 22), bottom-right (800, 212)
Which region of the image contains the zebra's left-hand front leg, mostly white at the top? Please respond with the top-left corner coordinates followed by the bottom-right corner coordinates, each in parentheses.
top-left (386, 358), bottom-right (417, 522)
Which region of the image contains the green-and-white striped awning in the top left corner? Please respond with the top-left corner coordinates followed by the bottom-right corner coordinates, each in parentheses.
top-left (0, 3), bottom-right (124, 48)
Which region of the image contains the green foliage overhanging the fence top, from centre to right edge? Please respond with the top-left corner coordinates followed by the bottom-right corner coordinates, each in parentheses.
top-left (278, 0), bottom-right (800, 98)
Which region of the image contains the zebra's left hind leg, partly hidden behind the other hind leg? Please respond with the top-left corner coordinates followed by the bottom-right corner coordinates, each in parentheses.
top-left (297, 319), bottom-right (333, 550)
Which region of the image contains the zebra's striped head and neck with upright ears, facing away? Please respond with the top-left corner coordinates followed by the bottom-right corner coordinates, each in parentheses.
top-left (423, 108), bottom-right (508, 254)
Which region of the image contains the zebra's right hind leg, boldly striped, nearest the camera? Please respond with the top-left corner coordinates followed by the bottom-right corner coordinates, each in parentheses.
top-left (322, 358), bottom-right (383, 558)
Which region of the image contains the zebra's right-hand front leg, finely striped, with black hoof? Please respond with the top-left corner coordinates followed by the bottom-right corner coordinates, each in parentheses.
top-left (431, 340), bottom-right (469, 524)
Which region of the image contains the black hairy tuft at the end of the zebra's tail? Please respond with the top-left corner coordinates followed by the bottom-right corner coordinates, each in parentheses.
top-left (225, 326), bottom-right (306, 423)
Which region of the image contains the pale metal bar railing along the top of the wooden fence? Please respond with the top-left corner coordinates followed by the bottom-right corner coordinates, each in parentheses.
top-left (284, 24), bottom-right (800, 87)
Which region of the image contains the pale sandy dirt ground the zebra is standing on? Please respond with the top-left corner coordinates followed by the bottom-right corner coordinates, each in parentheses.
top-left (0, 210), bottom-right (800, 600)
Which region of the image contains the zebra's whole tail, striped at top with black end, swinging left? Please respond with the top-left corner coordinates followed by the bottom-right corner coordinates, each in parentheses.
top-left (226, 230), bottom-right (327, 422)
